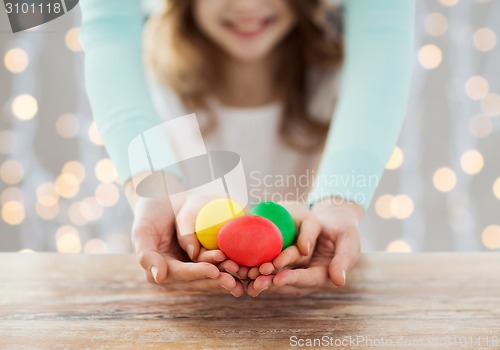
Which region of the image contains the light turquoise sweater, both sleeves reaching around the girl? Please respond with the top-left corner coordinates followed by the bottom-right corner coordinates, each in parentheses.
top-left (80, 0), bottom-right (415, 209)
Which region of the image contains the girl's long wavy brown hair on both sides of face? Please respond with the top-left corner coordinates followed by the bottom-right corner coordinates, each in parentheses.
top-left (147, 0), bottom-right (343, 152)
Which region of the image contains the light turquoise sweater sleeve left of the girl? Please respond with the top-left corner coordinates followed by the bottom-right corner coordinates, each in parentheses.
top-left (80, 0), bottom-right (175, 183)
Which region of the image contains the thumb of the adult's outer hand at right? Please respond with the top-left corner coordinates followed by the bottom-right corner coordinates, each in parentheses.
top-left (328, 229), bottom-right (361, 287)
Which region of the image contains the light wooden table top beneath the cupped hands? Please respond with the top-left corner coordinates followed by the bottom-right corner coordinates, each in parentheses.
top-left (0, 253), bottom-right (500, 349)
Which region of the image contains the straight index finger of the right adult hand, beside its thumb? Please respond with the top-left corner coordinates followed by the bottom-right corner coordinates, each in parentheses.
top-left (273, 266), bottom-right (329, 288)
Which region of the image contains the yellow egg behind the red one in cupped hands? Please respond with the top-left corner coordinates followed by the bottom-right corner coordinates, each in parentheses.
top-left (195, 198), bottom-right (244, 249)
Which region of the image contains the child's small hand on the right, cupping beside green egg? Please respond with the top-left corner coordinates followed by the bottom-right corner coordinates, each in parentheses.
top-left (248, 202), bottom-right (321, 280)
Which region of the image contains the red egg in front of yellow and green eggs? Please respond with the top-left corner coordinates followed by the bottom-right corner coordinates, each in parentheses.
top-left (217, 215), bottom-right (283, 267)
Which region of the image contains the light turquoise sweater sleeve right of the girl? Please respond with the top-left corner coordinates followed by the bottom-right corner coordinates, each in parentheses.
top-left (309, 0), bottom-right (415, 210)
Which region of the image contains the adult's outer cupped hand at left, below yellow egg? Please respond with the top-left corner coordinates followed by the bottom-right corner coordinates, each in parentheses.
top-left (125, 182), bottom-right (244, 296)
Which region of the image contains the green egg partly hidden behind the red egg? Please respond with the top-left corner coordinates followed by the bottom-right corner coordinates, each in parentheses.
top-left (250, 202), bottom-right (297, 249)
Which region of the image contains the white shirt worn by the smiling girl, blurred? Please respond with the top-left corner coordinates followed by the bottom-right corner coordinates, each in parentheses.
top-left (152, 69), bottom-right (338, 204)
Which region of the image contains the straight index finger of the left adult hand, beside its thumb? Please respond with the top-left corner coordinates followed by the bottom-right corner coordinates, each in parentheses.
top-left (166, 258), bottom-right (220, 282)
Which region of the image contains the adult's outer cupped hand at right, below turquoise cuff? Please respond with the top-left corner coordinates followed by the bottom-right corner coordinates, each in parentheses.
top-left (247, 200), bottom-right (363, 297)
